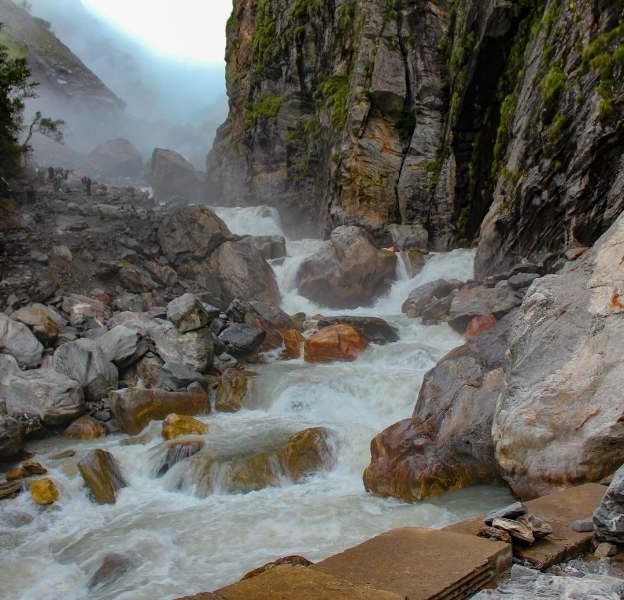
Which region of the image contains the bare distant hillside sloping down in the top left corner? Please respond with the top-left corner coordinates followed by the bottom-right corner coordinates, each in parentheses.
top-left (0, 0), bottom-right (125, 112)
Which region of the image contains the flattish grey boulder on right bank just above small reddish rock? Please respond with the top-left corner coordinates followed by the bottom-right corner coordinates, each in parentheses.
top-left (449, 282), bottom-right (522, 334)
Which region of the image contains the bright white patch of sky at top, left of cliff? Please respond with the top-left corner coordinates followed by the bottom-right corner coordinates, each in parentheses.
top-left (83, 0), bottom-right (232, 64)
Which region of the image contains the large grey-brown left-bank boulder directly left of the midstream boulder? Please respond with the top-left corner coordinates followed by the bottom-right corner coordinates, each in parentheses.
top-left (208, 238), bottom-right (281, 306)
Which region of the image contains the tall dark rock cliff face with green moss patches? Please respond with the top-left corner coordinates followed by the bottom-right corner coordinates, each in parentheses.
top-left (208, 0), bottom-right (624, 275)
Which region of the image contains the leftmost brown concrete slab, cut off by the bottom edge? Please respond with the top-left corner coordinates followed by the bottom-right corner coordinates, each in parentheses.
top-left (207, 565), bottom-right (404, 600)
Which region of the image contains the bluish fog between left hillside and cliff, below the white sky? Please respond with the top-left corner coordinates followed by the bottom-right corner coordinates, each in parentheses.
top-left (24, 0), bottom-right (229, 169)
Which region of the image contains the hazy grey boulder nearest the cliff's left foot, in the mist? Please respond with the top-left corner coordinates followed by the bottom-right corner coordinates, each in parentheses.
top-left (150, 148), bottom-right (207, 204)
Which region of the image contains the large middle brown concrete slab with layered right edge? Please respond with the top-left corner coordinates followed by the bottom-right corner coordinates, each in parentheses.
top-left (310, 528), bottom-right (512, 600)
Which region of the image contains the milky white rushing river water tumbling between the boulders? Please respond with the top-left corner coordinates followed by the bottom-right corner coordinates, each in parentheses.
top-left (0, 207), bottom-right (510, 600)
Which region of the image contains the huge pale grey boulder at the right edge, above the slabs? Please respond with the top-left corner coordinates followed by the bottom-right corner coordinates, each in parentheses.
top-left (492, 217), bottom-right (624, 498)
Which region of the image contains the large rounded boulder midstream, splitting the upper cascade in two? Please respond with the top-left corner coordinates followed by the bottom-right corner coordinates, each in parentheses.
top-left (297, 226), bottom-right (397, 308)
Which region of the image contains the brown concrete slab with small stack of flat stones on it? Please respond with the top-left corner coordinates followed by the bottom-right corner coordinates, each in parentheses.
top-left (444, 483), bottom-right (607, 569)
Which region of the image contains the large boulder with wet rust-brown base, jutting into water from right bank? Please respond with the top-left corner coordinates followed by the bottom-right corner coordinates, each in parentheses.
top-left (364, 315), bottom-right (513, 501)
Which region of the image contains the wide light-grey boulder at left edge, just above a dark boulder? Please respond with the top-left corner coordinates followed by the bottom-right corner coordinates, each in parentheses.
top-left (0, 369), bottom-right (85, 427)
